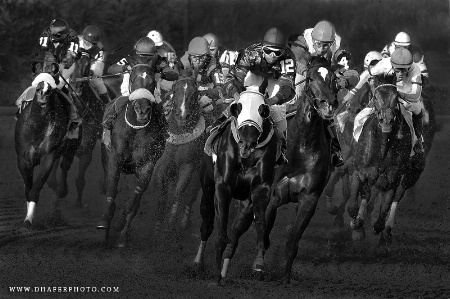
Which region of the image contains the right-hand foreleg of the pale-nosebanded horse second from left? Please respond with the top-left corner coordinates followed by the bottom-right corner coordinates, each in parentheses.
top-left (117, 163), bottom-right (154, 247)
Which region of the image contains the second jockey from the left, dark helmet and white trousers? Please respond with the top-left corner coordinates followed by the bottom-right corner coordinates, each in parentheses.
top-left (78, 25), bottom-right (111, 104)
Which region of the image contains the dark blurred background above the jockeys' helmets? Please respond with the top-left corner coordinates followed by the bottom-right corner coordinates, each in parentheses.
top-left (0, 0), bottom-right (450, 114)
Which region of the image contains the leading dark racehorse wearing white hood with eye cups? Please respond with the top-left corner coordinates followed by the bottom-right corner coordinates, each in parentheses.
top-left (195, 87), bottom-right (278, 284)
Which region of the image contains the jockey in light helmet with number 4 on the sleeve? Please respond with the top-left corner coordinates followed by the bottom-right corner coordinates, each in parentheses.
top-left (289, 20), bottom-right (359, 167)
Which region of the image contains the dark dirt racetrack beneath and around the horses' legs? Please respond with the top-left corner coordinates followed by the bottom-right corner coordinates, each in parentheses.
top-left (0, 108), bottom-right (450, 298)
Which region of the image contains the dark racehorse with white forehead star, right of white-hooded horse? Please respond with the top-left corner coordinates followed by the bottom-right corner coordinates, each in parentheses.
top-left (264, 58), bottom-right (337, 283)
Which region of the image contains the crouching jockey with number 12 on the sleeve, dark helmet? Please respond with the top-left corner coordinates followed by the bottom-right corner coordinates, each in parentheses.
top-left (209, 28), bottom-right (296, 165)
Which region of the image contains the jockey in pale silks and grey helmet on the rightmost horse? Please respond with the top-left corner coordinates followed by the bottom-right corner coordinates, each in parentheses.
top-left (343, 47), bottom-right (423, 153)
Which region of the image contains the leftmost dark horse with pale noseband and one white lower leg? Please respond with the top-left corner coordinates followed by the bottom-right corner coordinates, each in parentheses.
top-left (14, 52), bottom-right (78, 230)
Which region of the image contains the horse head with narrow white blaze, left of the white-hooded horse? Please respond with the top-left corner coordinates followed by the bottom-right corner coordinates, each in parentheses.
top-left (172, 76), bottom-right (201, 127)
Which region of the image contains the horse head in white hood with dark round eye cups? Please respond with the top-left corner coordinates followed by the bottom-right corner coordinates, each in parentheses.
top-left (230, 86), bottom-right (270, 158)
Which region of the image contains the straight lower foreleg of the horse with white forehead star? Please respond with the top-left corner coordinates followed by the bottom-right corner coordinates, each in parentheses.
top-left (282, 191), bottom-right (321, 283)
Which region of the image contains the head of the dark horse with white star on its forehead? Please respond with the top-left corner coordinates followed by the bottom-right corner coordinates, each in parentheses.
top-left (305, 57), bottom-right (338, 118)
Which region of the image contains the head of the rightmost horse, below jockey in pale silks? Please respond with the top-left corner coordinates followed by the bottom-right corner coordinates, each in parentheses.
top-left (371, 75), bottom-right (398, 133)
